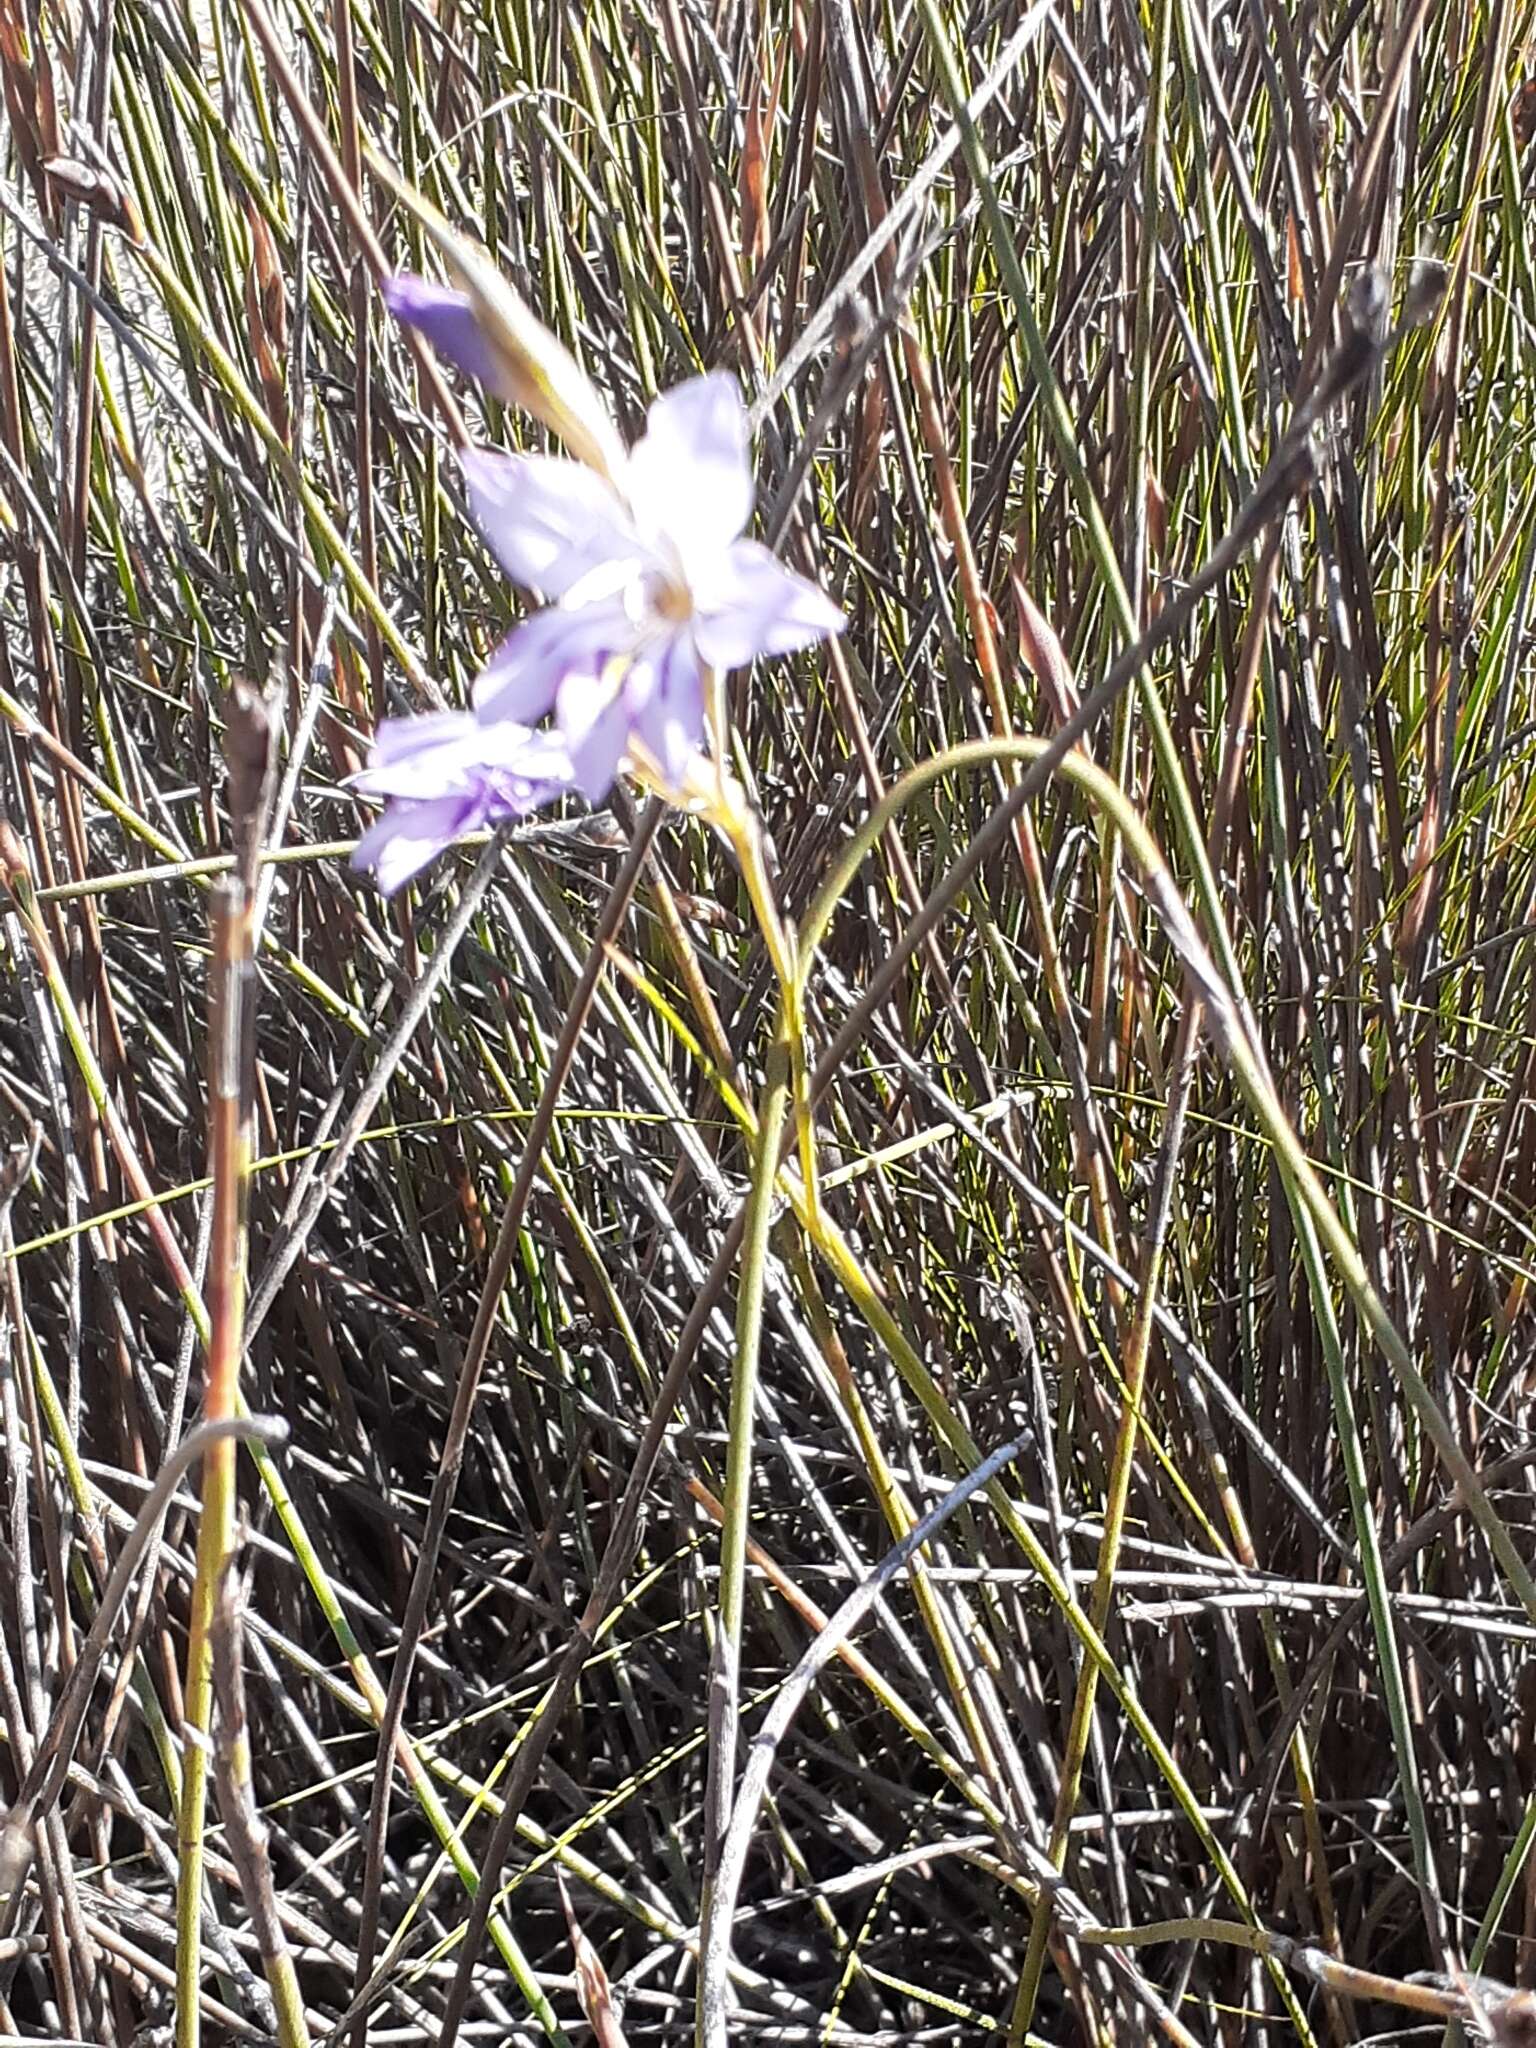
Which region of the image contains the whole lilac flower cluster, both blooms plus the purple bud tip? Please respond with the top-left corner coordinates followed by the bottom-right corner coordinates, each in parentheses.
top-left (354, 276), bottom-right (844, 891)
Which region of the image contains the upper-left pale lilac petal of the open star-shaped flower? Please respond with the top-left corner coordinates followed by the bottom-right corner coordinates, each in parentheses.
top-left (461, 449), bottom-right (647, 598)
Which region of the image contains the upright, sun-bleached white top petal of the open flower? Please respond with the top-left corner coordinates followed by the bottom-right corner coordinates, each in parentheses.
top-left (629, 373), bottom-right (754, 573)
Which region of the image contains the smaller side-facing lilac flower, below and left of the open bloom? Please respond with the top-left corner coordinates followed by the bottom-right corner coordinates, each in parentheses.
top-left (352, 711), bottom-right (571, 895)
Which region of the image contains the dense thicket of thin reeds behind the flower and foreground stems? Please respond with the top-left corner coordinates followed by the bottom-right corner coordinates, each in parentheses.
top-left (0, 0), bottom-right (1536, 2042)
